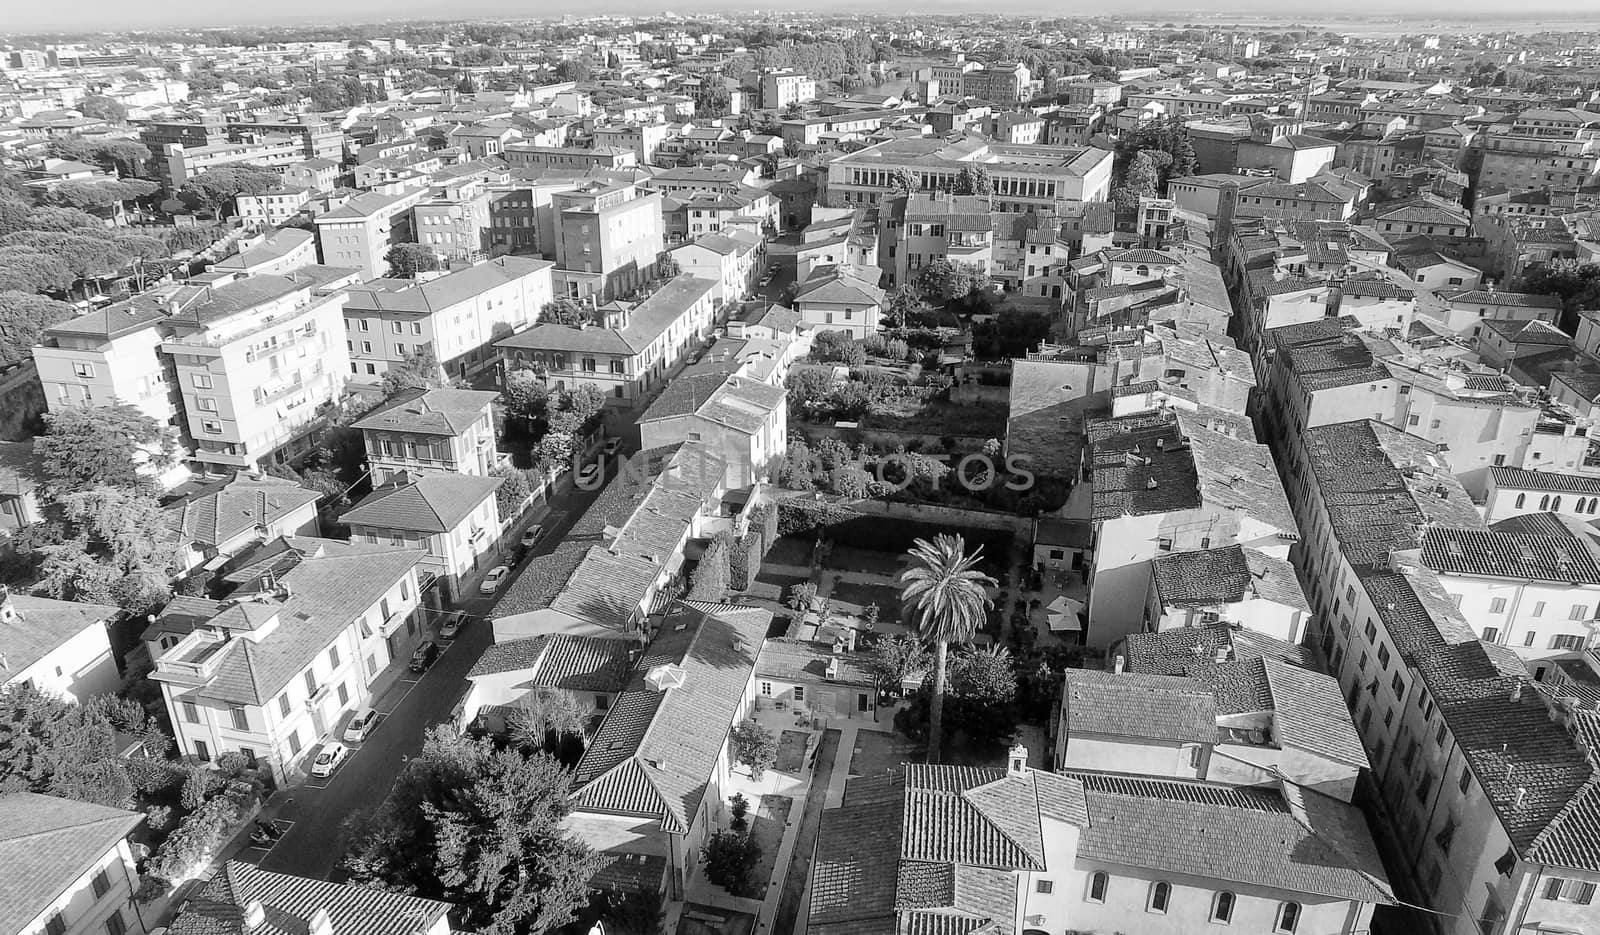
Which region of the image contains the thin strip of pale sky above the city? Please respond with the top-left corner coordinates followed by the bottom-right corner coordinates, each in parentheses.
top-left (9, 0), bottom-right (1597, 32)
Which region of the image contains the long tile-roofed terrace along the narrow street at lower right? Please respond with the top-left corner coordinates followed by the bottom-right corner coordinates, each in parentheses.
top-left (1290, 421), bottom-right (1600, 935)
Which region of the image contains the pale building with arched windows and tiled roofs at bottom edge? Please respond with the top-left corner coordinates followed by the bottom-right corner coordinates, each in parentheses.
top-left (808, 746), bottom-right (1395, 935)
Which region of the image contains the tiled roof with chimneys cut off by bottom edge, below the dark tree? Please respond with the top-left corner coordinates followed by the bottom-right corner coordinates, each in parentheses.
top-left (168, 860), bottom-right (451, 935)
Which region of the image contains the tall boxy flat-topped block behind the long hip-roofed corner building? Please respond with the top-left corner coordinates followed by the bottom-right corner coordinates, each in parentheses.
top-left (550, 181), bottom-right (664, 303)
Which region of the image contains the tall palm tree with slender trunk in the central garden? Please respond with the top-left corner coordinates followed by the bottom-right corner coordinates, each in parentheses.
top-left (901, 533), bottom-right (995, 764)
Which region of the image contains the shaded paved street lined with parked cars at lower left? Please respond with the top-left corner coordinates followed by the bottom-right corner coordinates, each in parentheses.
top-left (238, 471), bottom-right (611, 879)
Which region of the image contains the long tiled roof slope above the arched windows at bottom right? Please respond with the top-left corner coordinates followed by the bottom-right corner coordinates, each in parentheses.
top-left (1064, 772), bottom-right (1395, 905)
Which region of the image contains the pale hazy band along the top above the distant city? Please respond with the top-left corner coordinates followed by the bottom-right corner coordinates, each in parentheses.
top-left (5, 0), bottom-right (1600, 35)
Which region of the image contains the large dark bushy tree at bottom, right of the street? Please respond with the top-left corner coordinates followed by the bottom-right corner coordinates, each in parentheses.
top-left (344, 725), bottom-right (602, 935)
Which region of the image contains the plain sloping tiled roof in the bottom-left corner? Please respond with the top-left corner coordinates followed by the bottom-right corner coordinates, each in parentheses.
top-left (0, 793), bottom-right (144, 932)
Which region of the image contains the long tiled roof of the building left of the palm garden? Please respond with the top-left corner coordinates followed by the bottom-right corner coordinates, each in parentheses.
top-left (573, 605), bottom-right (771, 834)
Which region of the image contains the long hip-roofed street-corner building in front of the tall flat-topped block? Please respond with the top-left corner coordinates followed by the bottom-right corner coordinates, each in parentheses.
top-left (494, 275), bottom-right (717, 408)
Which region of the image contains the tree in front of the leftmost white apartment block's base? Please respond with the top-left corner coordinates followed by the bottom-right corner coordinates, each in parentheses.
top-left (34, 403), bottom-right (174, 496)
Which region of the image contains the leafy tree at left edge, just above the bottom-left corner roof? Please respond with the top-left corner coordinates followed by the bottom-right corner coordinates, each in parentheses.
top-left (0, 682), bottom-right (158, 809)
